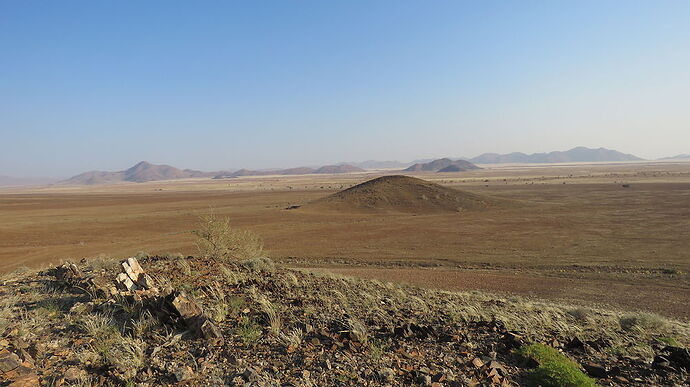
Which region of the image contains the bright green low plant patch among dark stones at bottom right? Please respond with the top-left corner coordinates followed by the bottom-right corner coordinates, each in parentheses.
top-left (518, 344), bottom-right (596, 387)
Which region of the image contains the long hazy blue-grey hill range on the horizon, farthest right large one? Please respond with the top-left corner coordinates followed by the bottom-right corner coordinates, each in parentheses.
top-left (470, 147), bottom-right (643, 164)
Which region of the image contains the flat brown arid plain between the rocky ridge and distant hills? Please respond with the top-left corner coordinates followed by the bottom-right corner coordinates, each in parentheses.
top-left (0, 162), bottom-right (690, 320)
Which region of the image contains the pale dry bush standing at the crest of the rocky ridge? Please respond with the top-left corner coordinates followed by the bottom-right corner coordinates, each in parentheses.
top-left (194, 214), bottom-right (264, 261)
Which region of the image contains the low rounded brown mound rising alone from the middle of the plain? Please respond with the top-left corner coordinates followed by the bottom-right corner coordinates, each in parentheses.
top-left (304, 175), bottom-right (500, 213)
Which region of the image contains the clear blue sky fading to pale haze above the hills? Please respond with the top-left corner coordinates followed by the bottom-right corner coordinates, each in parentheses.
top-left (0, 0), bottom-right (690, 177)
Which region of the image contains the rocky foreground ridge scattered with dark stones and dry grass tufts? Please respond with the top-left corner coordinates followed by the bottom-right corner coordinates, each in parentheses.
top-left (0, 255), bottom-right (690, 387)
